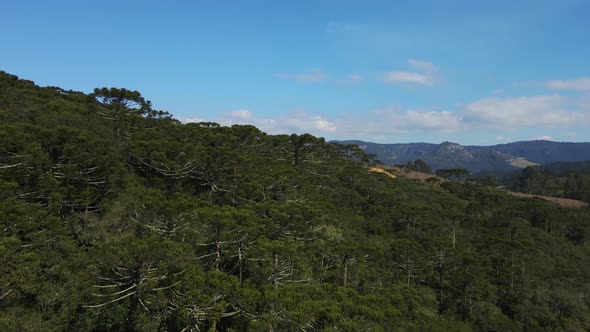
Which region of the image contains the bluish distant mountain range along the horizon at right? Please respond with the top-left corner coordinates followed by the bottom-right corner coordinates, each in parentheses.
top-left (338, 140), bottom-right (590, 175)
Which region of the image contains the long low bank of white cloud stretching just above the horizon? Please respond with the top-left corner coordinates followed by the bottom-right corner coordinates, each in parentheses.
top-left (181, 91), bottom-right (590, 142)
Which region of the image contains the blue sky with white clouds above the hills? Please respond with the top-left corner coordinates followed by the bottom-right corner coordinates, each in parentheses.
top-left (0, 0), bottom-right (590, 144)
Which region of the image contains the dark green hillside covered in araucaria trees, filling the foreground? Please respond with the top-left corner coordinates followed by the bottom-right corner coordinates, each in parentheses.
top-left (0, 73), bottom-right (590, 331)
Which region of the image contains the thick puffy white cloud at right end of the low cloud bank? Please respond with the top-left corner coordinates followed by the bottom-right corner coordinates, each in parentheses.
top-left (465, 95), bottom-right (585, 128)
